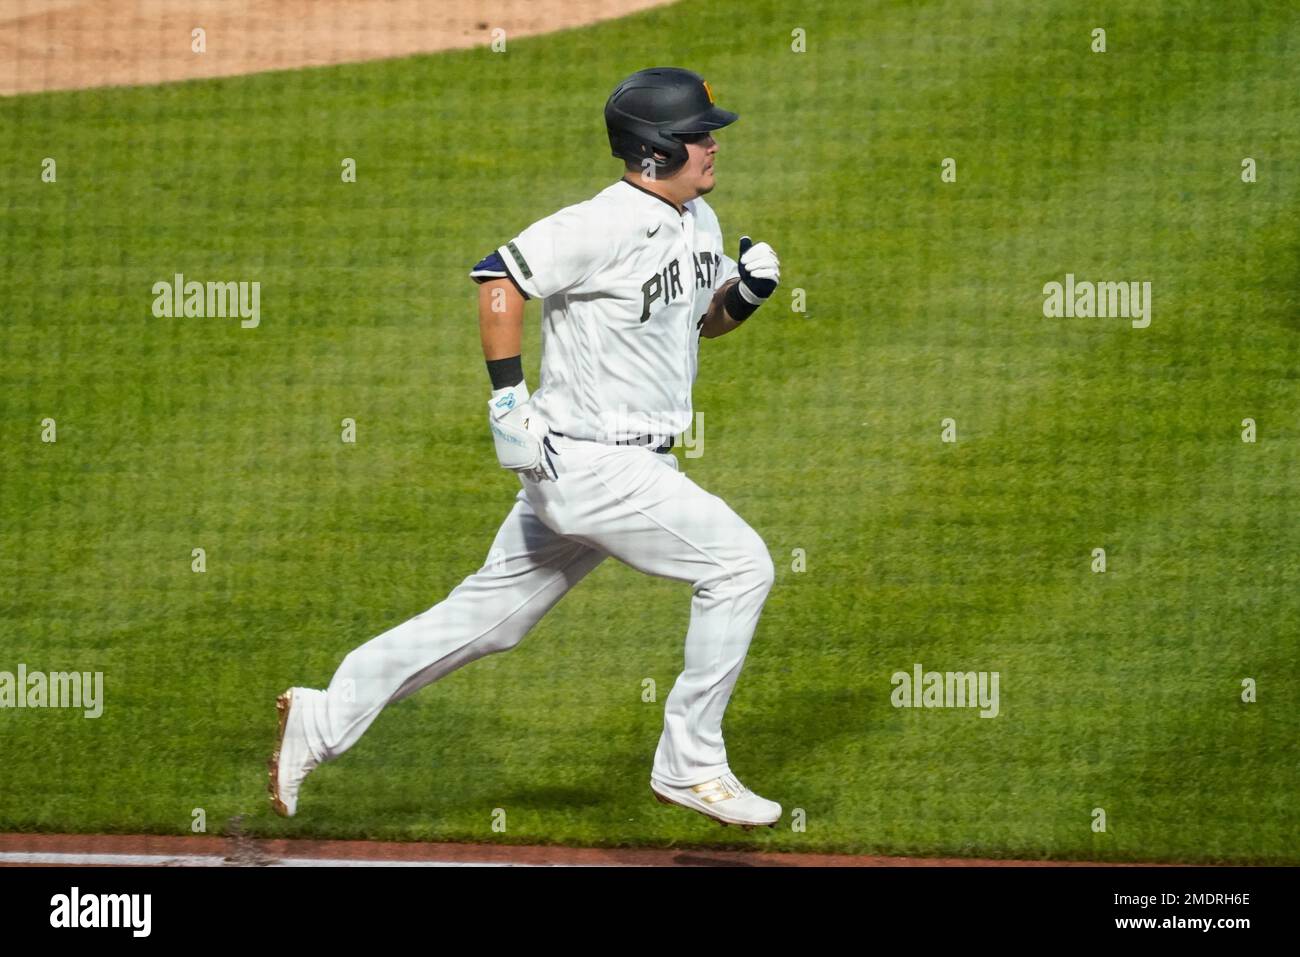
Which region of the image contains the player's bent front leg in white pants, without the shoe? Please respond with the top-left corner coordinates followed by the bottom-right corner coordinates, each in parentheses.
top-left (525, 438), bottom-right (775, 787)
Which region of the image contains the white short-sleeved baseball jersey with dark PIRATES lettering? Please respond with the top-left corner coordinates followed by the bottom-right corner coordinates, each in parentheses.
top-left (471, 179), bottom-right (737, 442)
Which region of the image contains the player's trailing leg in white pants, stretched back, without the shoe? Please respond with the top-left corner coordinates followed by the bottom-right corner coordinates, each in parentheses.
top-left (295, 493), bottom-right (605, 761)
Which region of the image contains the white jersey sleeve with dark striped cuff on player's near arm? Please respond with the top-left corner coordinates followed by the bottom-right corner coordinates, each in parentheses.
top-left (497, 203), bottom-right (611, 299)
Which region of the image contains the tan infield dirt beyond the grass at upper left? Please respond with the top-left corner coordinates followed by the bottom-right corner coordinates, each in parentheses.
top-left (0, 0), bottom-right (671, 95)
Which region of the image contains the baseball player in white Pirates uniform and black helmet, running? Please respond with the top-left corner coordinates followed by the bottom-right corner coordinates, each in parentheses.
top-left (270, 68), bottom-right (781, 828)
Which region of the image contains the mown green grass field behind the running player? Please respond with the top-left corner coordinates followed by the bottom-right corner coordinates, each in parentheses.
top-left (0, 0), bottom-right (1300, 863)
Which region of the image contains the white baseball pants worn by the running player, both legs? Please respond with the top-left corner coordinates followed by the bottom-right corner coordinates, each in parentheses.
top-left (295, 433), bottom-right (775, 787)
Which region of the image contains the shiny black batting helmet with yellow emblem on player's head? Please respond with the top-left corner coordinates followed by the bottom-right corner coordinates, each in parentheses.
top-left (605, 66), bottom-right (740, 176)
